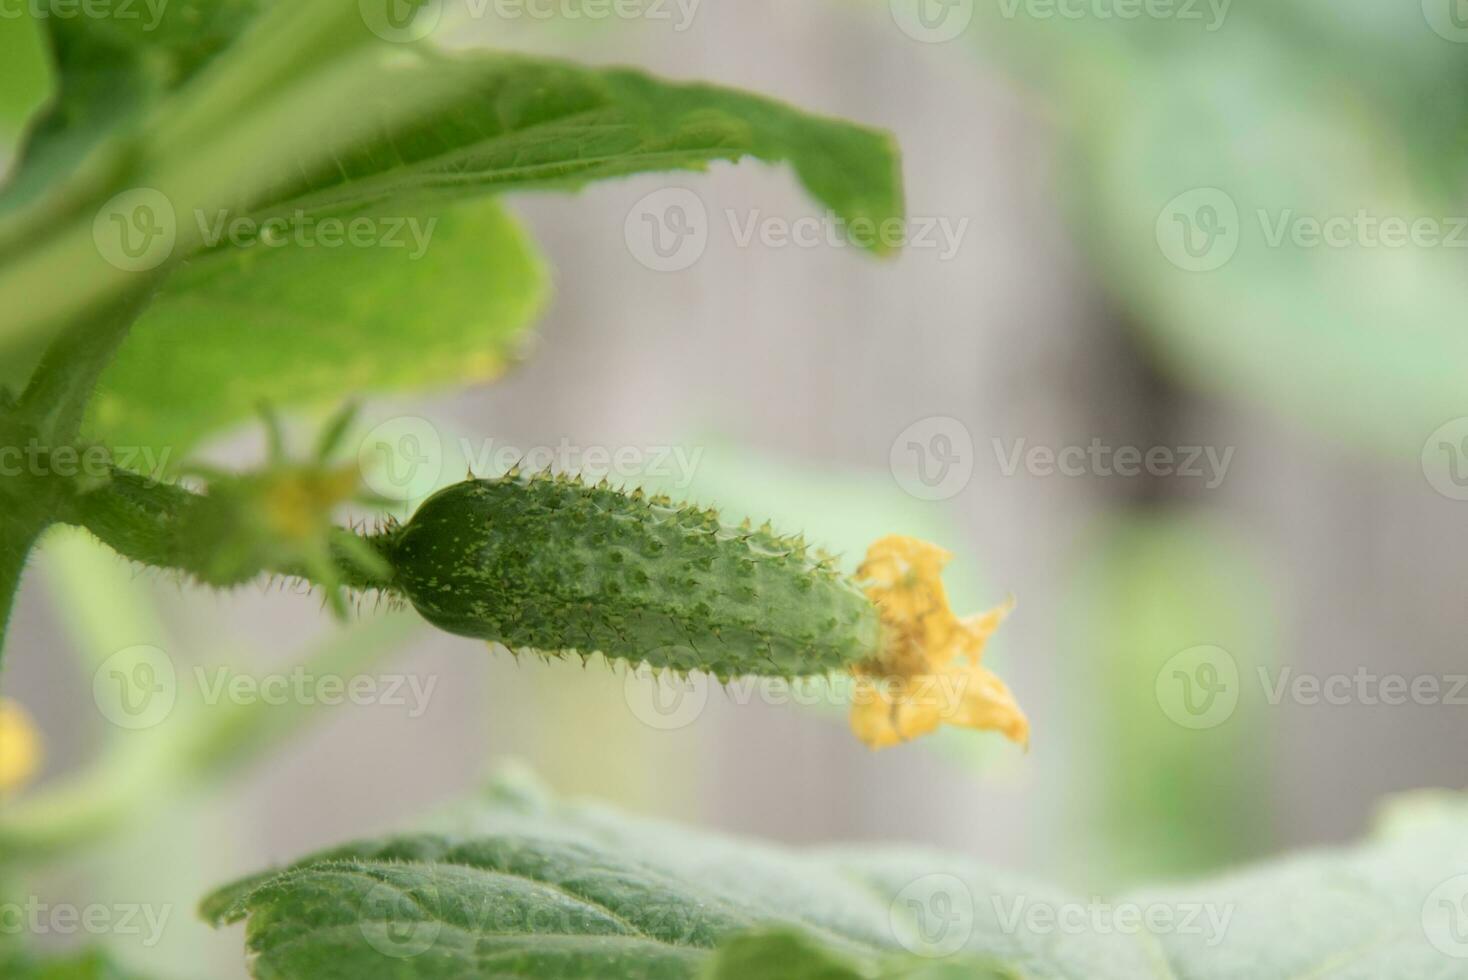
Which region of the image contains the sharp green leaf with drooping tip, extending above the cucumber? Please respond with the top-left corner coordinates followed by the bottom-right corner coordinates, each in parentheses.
top-left (246, 51), bottom-right (903, 246)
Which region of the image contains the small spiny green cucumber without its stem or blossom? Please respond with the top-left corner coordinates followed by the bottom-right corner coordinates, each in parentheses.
top-left (383, 475), bottom-right (879, 679)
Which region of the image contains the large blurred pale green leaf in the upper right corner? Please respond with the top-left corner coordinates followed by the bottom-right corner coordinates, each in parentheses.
top-left (939, 0), bottom-right (1468, 456)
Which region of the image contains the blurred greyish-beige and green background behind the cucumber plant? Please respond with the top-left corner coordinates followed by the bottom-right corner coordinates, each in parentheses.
top-left (0, 0), bottom-right (1468, 977)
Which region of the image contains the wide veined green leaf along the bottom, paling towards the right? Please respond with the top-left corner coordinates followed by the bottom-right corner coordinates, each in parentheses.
top-left (203, 785), bottom-right (1468, 980)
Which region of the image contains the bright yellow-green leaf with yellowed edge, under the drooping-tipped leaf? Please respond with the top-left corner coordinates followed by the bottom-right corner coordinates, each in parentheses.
top-left (84, 201), bottom-right (548, 465)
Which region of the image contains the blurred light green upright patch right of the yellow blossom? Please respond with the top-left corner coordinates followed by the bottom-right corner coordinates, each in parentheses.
top-left (1061, 513), bottom-right (1274, 882)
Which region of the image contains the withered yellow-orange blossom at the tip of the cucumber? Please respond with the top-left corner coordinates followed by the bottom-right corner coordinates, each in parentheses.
top-left (851, 535), bottom-right (1029, 748)
